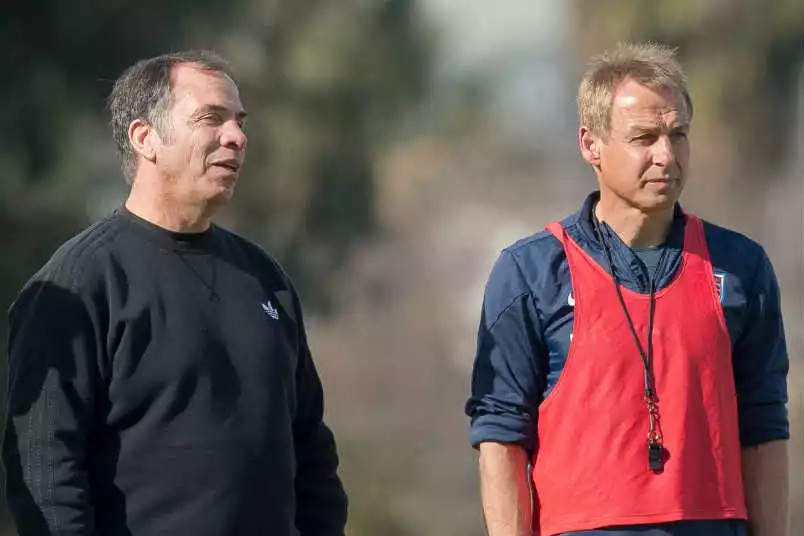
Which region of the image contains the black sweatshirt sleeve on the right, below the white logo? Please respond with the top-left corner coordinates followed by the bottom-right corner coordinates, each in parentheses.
top-left (293, 288), bottom-right (347, 536)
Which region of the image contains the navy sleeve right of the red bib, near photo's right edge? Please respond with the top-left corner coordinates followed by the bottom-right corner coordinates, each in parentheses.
top-left (733, 251), bottom-right (790, 446)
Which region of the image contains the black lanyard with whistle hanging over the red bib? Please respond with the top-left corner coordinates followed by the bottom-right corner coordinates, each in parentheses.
top-left (594, 216), bottom-right (667, 473)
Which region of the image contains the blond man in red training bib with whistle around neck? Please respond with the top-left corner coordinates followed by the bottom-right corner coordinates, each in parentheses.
top-left (466, 44), bottom-right (789, 536)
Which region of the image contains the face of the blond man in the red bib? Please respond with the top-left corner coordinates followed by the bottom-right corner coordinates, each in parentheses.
top-left (597, 80), bottom-right (690, 212)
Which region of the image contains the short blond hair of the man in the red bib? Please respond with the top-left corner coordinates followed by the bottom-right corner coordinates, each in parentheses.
top-left (578, 43), bottom-right (692, 137)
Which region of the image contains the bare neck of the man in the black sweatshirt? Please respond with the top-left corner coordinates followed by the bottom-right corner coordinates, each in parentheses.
top-left (125, 180), bottom-right (212, 233)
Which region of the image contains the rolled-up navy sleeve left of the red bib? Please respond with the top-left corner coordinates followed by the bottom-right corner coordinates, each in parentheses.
top-left (465, 251), bottom-right (546, 452)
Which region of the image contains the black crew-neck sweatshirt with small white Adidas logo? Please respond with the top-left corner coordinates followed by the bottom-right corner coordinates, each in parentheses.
top-left (2, 208), bottom-right (346, 536)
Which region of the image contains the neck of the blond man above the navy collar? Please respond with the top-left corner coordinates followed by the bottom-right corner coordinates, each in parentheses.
top-left (594, 197), bottom-right (673, 248)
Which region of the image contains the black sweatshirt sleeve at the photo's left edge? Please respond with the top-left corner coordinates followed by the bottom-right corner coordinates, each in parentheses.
top-left (2, 281), bottom-right (98, 536)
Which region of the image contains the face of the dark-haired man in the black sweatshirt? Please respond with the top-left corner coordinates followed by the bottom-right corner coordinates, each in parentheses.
top-left (156, 64), bottom-right (246, 204)
